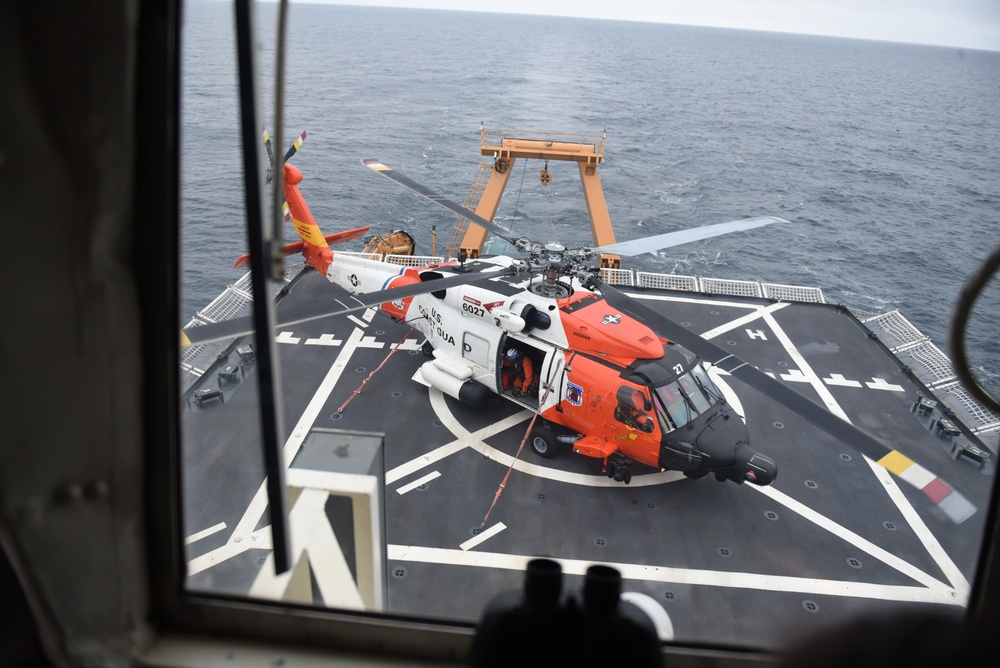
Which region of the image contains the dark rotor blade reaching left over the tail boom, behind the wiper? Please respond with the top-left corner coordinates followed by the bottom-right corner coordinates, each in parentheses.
top-left (181, 260), bottom-right (517, 347)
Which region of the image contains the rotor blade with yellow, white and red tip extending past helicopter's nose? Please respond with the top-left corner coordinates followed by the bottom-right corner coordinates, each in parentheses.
top-left (600, 283), bottom-right (976, 524)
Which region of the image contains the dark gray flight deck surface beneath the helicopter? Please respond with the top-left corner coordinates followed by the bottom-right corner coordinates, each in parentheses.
top-left (183, 273), bottom-right (993, 648)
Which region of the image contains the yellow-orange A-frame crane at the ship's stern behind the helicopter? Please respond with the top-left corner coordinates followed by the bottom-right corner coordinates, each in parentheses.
top-left (448, 127), bottom-right (621, 269)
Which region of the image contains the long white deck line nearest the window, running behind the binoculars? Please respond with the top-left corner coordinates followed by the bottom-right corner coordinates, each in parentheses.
top-left (388, 545), bottom-right (960, 605)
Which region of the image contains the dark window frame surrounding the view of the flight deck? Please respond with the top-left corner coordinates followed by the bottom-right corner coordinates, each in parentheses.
top-left (134, 0), bottom-right (1000, 666)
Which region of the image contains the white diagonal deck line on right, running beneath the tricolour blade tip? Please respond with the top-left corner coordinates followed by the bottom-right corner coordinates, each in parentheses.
top-left (764, 313), bottom-right (969, 592)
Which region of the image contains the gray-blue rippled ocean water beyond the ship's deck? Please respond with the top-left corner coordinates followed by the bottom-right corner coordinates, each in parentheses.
top-left (181, 2), bottom-right (1000, 393)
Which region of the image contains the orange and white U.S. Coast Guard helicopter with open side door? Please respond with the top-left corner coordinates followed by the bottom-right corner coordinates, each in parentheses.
top-left (183, 140), bottom-right (975, 522)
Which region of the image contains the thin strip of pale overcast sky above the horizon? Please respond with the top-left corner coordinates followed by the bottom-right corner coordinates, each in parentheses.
top-left (301, 0), bottom-right (1000, 51)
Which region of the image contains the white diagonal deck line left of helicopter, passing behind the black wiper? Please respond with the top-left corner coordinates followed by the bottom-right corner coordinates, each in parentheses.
top-left (188, 329), bottom-right (363, 576)
